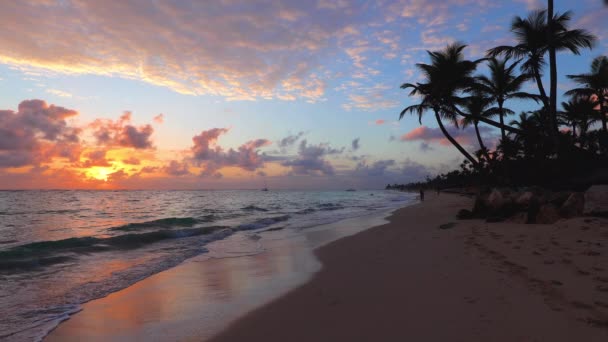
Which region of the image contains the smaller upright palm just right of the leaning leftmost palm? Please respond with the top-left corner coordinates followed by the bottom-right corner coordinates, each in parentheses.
top-left (475, 57), bottom-right (538, 139)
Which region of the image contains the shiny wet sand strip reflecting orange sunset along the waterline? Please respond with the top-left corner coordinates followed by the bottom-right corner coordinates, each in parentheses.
top-left (47, 210), bottom-right (385, 341)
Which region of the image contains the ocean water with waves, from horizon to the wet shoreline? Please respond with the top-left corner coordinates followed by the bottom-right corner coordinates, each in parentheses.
top-left (0, 190), bottom-right (414, 340)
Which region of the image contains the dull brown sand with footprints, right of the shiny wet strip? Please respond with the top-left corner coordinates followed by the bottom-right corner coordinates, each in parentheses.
top-left (212, 194), bottom-right (608, 341)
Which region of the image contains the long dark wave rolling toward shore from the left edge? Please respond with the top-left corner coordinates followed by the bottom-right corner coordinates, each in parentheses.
top-left (0, 226), bottom-right (229, 271)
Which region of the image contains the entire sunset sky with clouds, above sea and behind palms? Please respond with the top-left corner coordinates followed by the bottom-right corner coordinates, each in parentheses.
top-left (0, 0), bottom-right (608, 189)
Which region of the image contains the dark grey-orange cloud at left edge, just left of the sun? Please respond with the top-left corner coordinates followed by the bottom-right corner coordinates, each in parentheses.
top-left (0, 100), bottom-right (81, 168)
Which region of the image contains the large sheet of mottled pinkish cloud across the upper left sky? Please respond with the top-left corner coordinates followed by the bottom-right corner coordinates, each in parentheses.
top-left (0, 0), bottom-right (368, 102)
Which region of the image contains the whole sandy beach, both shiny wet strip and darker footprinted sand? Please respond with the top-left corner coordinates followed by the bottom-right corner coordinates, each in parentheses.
top-left (48, 194), bottom-right (608, 341)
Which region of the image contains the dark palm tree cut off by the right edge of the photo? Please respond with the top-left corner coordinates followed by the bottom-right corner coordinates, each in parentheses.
top-left (566, 56), bottom-right (608, 134)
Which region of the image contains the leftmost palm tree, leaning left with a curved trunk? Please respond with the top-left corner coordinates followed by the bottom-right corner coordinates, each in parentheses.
top-left (399, 43), bottom-right (480, 166)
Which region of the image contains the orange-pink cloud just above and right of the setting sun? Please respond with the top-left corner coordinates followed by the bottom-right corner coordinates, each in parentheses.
top-left (90, 111), bottom-right (154, 149)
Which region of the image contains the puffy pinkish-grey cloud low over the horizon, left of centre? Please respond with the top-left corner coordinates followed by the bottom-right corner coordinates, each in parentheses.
top-left (191, 128), bottom-right (271, 176)
